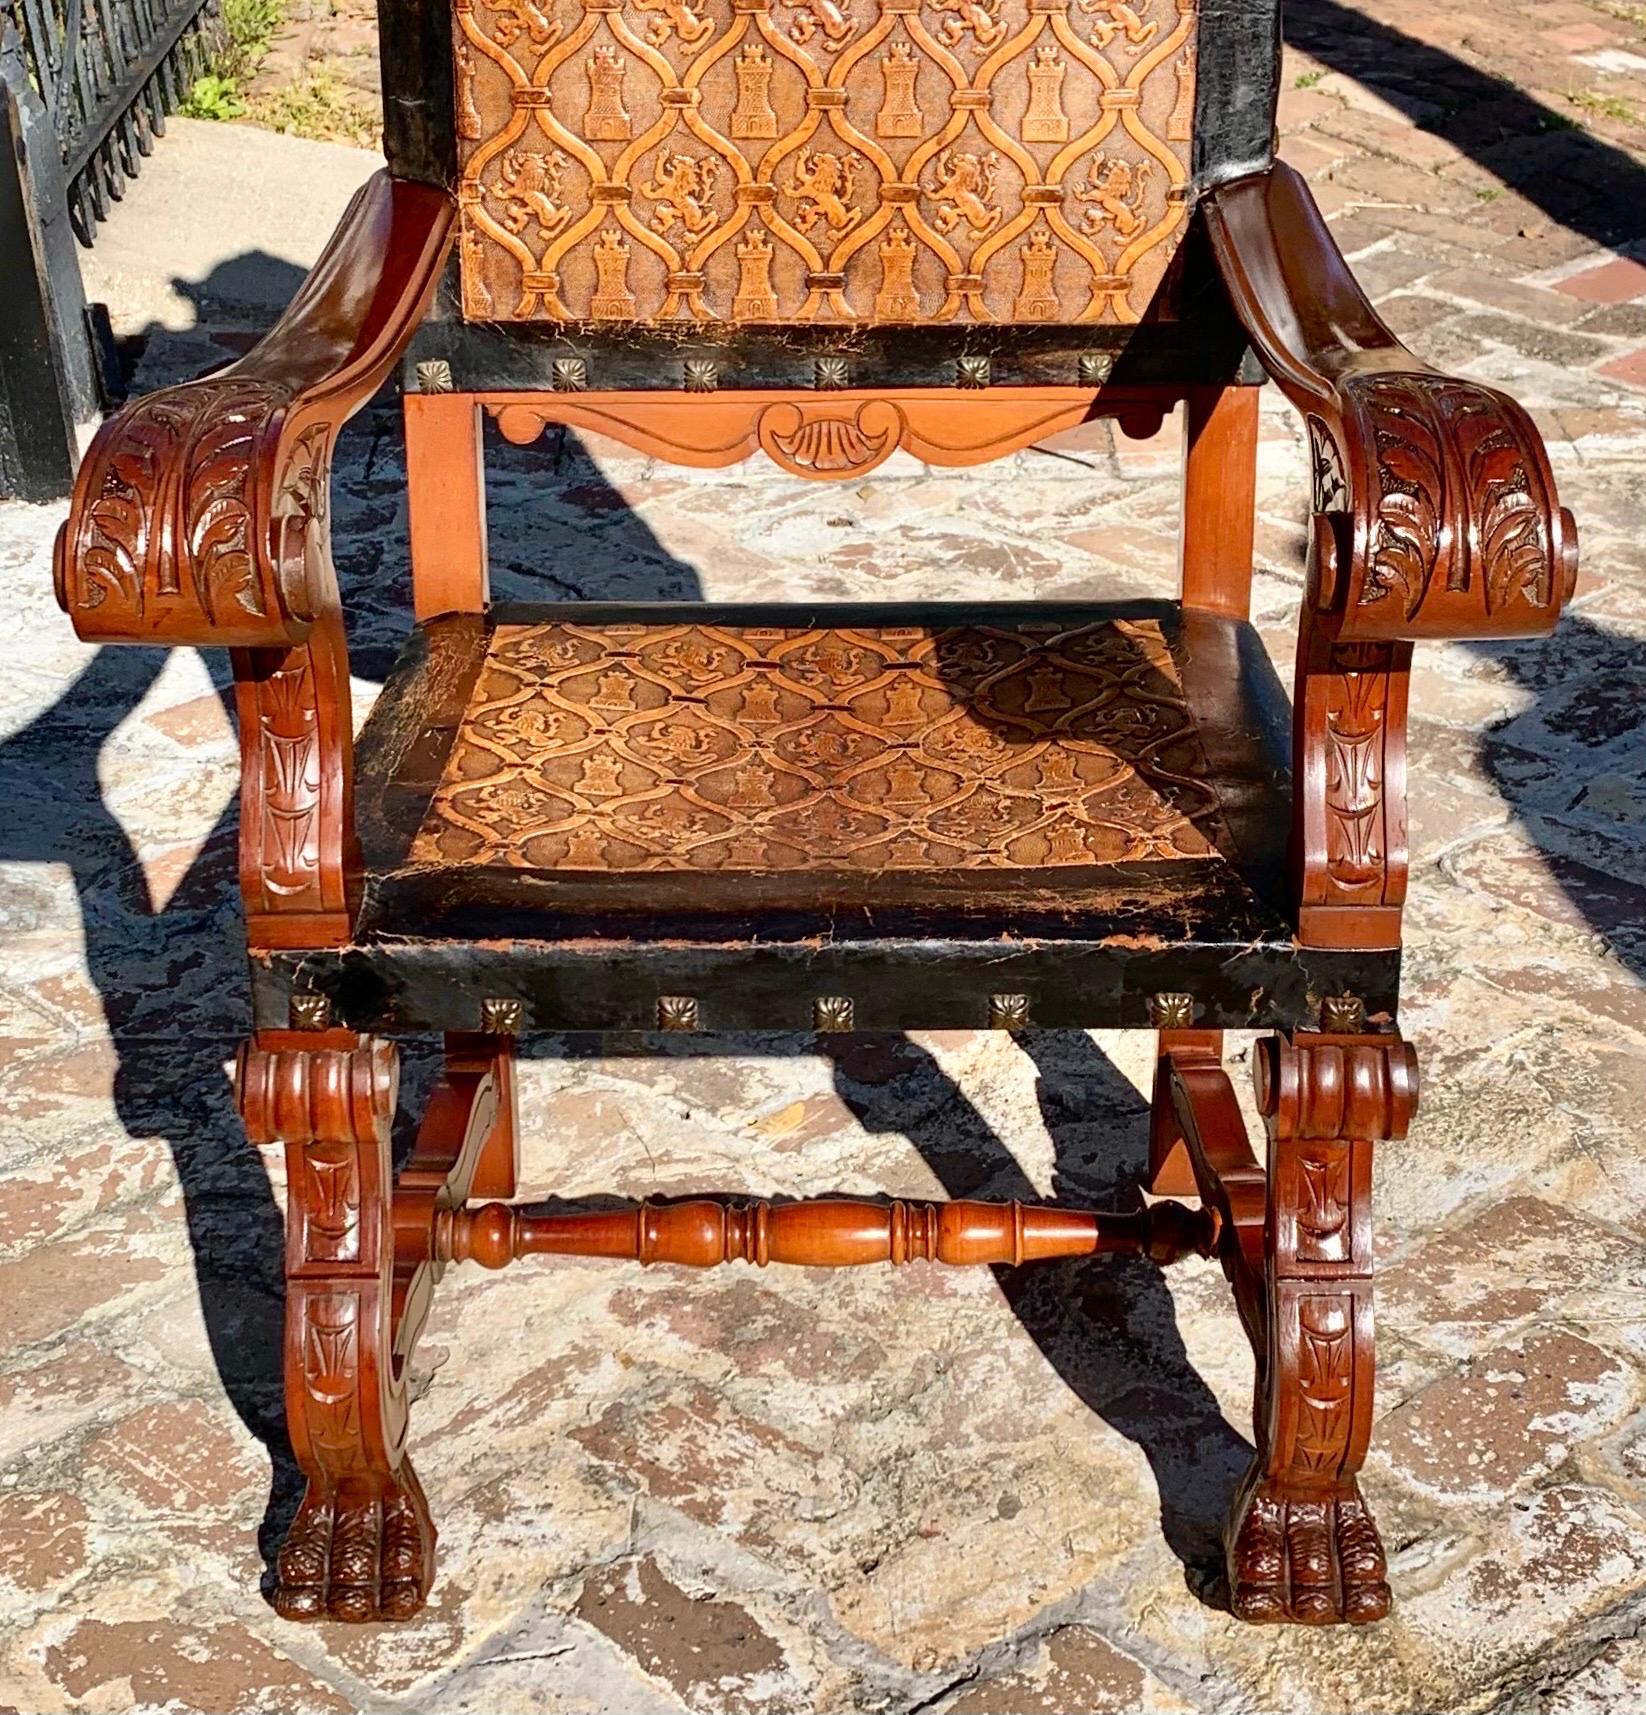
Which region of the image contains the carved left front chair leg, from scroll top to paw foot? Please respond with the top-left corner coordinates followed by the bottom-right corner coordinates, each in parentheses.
top-left (235, 1031), bottom-right (434, 1621)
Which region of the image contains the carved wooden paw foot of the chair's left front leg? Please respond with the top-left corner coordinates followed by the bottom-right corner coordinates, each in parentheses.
top-left (274, 1461), bottom-right (434, 1622)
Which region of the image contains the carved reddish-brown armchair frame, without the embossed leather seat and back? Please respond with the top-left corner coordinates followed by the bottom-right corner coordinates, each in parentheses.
top-left (57, 0), bottom-right (1576, 1624)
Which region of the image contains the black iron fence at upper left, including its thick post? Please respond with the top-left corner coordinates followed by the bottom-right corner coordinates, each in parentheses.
top-left (0, 0), bottom-right (221, 501)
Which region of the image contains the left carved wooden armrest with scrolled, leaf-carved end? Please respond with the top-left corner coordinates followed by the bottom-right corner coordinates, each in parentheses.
top-left (55, 173), bottom-right (454, 647)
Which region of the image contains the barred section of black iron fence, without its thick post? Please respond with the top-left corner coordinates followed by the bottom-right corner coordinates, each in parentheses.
top-left (0, 0), bottom-right (221, 244)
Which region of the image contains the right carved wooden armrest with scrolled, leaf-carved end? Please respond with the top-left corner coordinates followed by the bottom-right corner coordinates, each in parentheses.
top-left (1205, 166), bottom-right (1577, 643)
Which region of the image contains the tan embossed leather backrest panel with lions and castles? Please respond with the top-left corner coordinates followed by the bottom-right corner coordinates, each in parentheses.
top-left (453, 0), bottom-right (1197, 324)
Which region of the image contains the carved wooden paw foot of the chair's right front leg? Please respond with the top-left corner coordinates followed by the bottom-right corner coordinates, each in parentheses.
top-left (1228, 1480), bottom-right (1389, 1626)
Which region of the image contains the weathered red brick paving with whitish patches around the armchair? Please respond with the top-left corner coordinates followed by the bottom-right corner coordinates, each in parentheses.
top-left (0, 0), bottom-right (1646, 1715)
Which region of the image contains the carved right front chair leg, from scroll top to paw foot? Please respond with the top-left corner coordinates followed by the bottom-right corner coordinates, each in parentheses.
top-left (1226, 1032), bottom-right (1416, 1626)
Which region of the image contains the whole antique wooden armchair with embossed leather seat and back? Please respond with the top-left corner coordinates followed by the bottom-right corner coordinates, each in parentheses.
top-left (57, 0), bottom-right (1576, 1624)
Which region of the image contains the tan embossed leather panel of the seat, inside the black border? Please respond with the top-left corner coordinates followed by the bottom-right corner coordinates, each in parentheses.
top-left (410, 621), bottom-right (1228, 875)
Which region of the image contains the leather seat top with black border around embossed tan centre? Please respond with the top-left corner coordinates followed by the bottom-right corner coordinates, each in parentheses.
top-left (349, 604), bottom-right (1291, 953)
